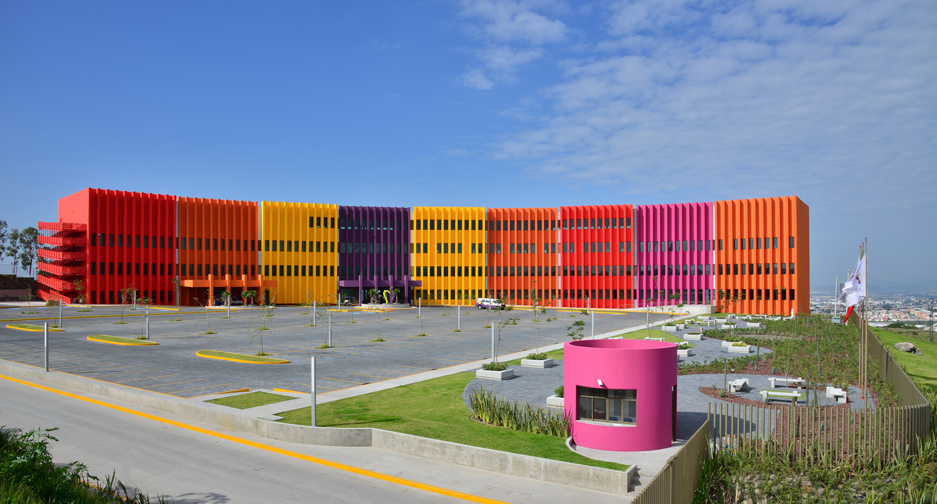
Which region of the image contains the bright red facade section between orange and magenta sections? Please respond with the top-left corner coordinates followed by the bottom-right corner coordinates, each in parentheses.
top-left (559, 205), bottom-right (634, 308)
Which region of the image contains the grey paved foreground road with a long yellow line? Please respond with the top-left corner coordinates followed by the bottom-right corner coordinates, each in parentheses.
top-left (0, 370), bottom-right (622, 504)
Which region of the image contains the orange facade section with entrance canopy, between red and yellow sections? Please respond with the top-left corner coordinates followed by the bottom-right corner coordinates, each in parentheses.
top-left (176, 198), bottom-right (260, 305)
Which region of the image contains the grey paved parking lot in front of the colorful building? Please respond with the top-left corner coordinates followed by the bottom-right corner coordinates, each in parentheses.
top-left (0, 306), bottom-right (669, 398)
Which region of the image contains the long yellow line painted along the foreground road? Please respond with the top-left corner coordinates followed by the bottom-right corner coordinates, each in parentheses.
top-left (0, 375), bottom-right (505, 504)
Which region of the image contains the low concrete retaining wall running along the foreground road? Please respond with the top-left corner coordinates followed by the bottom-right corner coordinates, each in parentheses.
top-left (0, 360), bottom-right (635, 494)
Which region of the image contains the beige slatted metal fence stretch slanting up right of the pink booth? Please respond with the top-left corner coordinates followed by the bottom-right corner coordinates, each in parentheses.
top-left (632, 420), bottom-right (710, 504)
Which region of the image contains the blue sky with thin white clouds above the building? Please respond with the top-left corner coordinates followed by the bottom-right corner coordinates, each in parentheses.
top-left (0, 0), bottom-right (937, 294)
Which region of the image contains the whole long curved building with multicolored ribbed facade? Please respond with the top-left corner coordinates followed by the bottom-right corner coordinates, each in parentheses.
top-left (38, 189), bottom-right (810, 314)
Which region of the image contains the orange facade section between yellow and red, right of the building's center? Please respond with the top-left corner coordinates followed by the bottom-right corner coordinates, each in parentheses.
top-left (488, 208), bottom-right (559, 306)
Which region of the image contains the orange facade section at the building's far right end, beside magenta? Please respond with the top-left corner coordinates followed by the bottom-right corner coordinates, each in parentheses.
top-left (713, 196), bottom-right (810, 315)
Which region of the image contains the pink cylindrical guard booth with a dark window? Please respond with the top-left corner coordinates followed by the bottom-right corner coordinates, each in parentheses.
top-left (563, 340), bottom-right (677, 451)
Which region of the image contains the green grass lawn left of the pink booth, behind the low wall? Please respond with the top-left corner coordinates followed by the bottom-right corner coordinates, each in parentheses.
top-left (277, 373), bottom-right (628, 470)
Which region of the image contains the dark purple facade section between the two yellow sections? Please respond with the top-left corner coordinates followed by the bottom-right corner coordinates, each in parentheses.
top-left (338, 206), bottom-right (414, 302)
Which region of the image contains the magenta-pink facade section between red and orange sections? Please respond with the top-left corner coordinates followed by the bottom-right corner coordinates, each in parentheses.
top-left (634, 203), bottom-right (714, 307)
